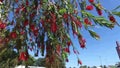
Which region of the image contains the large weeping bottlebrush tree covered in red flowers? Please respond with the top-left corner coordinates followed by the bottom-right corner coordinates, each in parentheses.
top-left (0, 0), bottom-right (120, 68)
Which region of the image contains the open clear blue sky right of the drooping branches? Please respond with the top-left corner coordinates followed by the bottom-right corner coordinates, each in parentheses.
top-left (66, 0), bottom-right (120, 68)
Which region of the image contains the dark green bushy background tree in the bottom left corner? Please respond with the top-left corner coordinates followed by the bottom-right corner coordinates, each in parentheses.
top-left (0, 48), bottom-right (18, 68)
